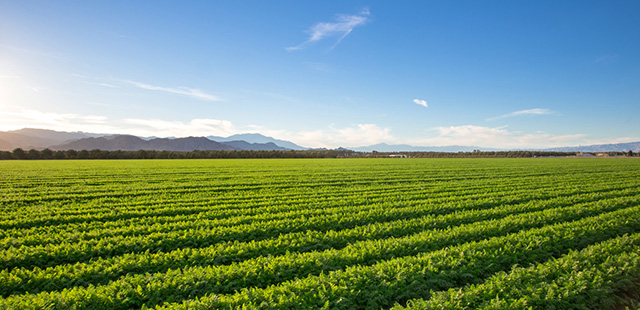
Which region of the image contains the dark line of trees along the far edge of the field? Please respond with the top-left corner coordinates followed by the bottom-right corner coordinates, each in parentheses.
top-left (0, 148), bottom-right (636, 160)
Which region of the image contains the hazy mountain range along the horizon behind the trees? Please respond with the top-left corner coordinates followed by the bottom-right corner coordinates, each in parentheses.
top-left (0, 128), bottom-right (640, 153)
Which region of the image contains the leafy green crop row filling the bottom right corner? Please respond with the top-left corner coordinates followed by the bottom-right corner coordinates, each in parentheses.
top-left (393, 233), bottom-right (640, 310)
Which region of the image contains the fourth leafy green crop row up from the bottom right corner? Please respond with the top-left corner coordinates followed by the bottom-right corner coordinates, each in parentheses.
top-left (0, 193), bottom-right (640, 296)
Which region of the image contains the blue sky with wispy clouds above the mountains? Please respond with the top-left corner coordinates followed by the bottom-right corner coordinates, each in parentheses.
top-left (0, 0), bottom-right (640, 149)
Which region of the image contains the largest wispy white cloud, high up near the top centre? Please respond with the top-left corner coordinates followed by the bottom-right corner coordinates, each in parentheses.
top-left (286, 9), bottom-right (370, 51)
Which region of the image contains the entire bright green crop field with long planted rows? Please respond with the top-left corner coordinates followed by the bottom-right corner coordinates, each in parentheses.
top-left (0, 159), bottom-right (640, 309)
